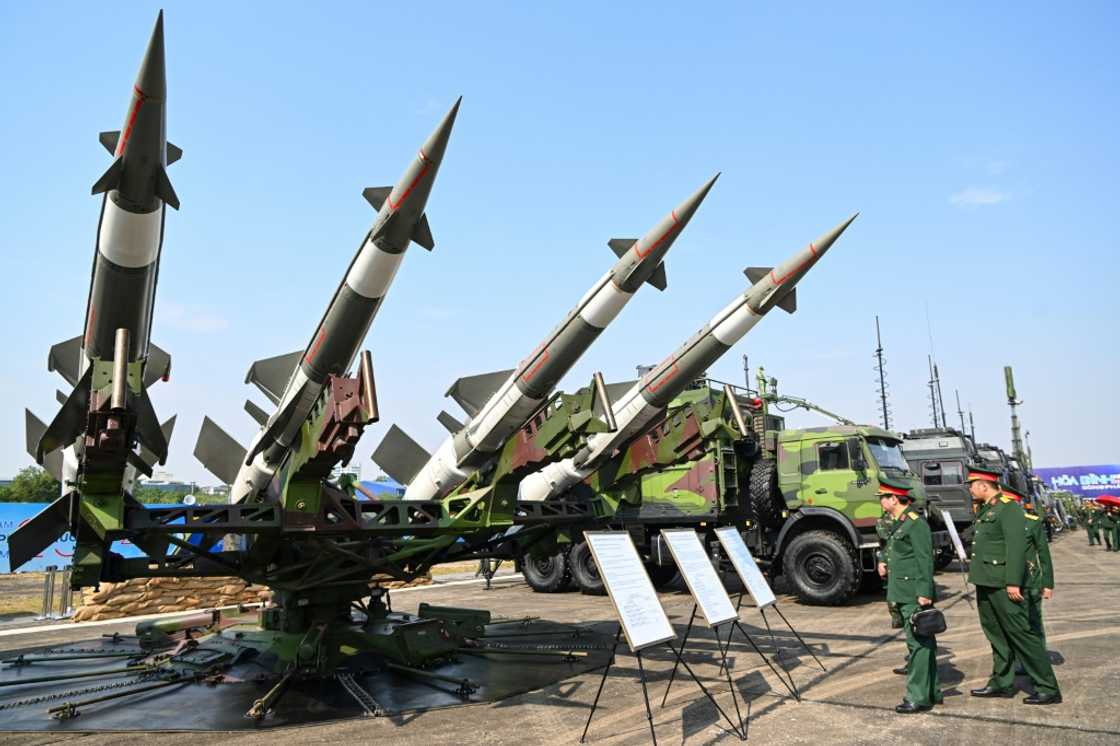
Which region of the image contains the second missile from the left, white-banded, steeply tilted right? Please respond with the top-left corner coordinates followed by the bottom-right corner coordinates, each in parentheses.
top-left (195, 97), bottom-right (461, 502)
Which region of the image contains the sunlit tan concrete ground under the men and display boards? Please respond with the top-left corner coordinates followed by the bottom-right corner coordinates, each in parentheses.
top-left (0, 532), bottom-right (1120, 746)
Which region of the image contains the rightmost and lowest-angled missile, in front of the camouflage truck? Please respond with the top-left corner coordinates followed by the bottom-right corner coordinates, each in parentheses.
top-left (517, 213), bottom-right (858, 502)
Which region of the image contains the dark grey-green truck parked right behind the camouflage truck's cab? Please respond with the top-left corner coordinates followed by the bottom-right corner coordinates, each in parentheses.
top-left (903, 428), bottom-right (988, 569)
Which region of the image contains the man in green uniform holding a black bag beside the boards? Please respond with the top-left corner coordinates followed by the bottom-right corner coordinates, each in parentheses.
top-left (879, 474), bottom-right (942, 715)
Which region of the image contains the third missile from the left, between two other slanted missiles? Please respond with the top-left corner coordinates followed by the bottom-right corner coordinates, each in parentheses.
top-left (373, 174), bottom-right (719, 500)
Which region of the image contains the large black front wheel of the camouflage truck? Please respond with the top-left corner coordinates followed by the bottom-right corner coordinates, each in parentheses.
top-left (782, 531), bottom-right (861, 606)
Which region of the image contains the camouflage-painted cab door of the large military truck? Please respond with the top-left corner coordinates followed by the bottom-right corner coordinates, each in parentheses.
top-left (801, 438), bottom-right (880, 517)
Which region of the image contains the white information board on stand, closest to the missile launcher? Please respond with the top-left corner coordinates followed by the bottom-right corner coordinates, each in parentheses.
top-left (584, 531), bottom-right (676, 652)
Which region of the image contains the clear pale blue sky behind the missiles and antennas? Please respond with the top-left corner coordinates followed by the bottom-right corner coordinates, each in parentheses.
top-left (0, 2), bottom-right (1120, 483)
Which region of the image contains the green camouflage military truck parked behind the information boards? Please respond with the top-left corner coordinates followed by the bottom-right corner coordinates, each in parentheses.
top-left (520, 379), bottom-right (931, 605)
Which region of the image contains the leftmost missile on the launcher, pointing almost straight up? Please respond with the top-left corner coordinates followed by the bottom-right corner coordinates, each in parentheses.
top-left (9, 11), bottom-right (183, 569)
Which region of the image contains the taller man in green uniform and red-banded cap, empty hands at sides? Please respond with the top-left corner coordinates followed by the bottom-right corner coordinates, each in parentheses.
top-left (969, 467), bottom-right (1062, 705)
